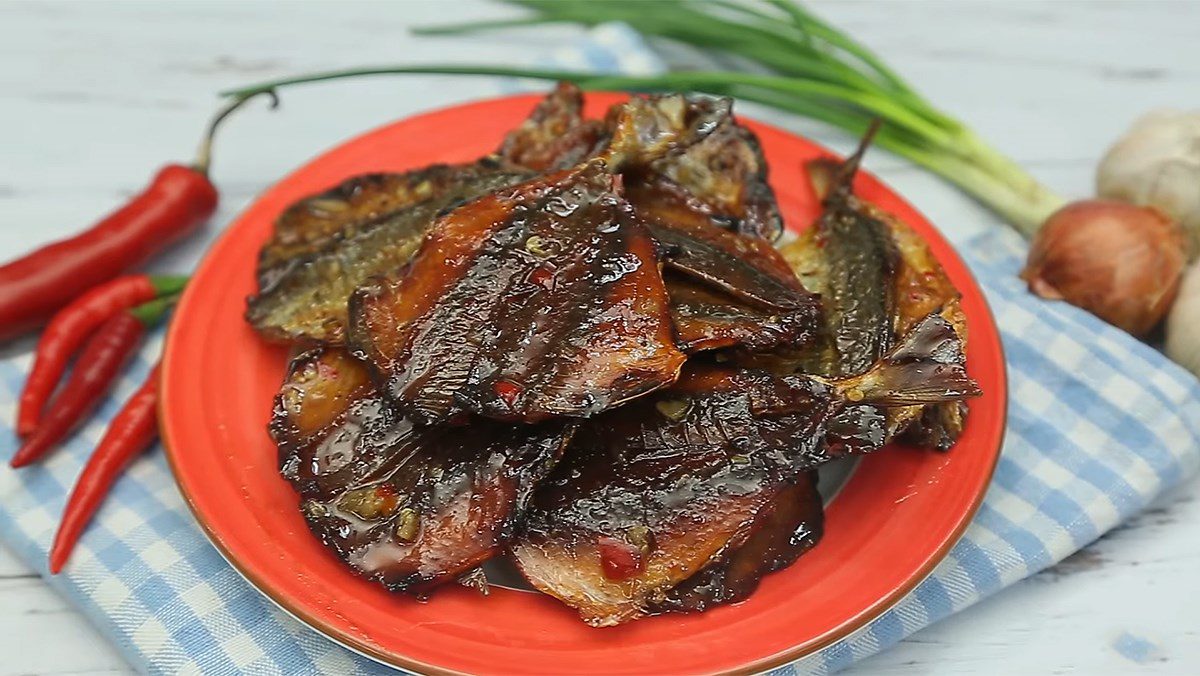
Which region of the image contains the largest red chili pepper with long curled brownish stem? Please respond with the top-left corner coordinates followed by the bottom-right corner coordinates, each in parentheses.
top-left (0, 92), bottom-right (277, 340)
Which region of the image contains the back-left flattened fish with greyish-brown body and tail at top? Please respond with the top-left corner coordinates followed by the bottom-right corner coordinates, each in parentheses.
top-left (247, 84), bottom-right (633, 342)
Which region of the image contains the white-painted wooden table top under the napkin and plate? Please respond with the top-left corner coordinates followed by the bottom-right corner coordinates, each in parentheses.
top-left (0, 0), bottom-right (1200, 674)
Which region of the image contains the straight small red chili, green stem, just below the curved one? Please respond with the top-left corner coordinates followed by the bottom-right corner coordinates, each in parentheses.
top-left (10, 297), bottom-right (176, 467)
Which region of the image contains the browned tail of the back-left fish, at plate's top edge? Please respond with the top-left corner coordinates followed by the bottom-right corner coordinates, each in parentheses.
top-left (497, 82), bottom-right (608, 172)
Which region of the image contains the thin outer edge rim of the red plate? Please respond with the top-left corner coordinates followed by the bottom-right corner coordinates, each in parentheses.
top-left (157, 91), bottom-right (1010, 676)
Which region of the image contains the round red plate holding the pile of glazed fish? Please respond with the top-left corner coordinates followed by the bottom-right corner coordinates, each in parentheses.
top-left (162, 94), bottom-right (1006, 675)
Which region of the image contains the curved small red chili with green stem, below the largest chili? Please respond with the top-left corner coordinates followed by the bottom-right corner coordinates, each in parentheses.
top-left (17, 275), bottom-right (187, 438)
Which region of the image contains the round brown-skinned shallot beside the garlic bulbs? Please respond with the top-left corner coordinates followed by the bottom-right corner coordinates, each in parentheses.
top-left (1021, 199), bottom-right (1187, 336)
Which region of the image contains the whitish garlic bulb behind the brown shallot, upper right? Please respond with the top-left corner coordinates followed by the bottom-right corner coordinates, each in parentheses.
top-left (1096, 110), bottom-right (1200, 256)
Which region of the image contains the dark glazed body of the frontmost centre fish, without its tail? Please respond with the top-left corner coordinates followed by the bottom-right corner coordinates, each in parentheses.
top-left (512, 366), bottom-right (830, 627)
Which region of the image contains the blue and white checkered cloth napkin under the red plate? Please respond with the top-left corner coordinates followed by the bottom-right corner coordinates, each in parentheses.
top-left (0, 26), bottom-right (1200, 675)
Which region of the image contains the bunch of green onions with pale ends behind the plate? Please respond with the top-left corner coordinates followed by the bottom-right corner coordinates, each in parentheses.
top-left (222, 0), bottom-right (1063, 235)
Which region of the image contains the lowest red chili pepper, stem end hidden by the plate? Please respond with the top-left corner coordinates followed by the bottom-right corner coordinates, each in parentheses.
top-left (50, 365), bottom-right (158, 575)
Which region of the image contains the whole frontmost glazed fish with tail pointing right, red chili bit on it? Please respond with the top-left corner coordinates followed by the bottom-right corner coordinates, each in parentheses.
top-left (514, 315), bottom-right (978, 626)
